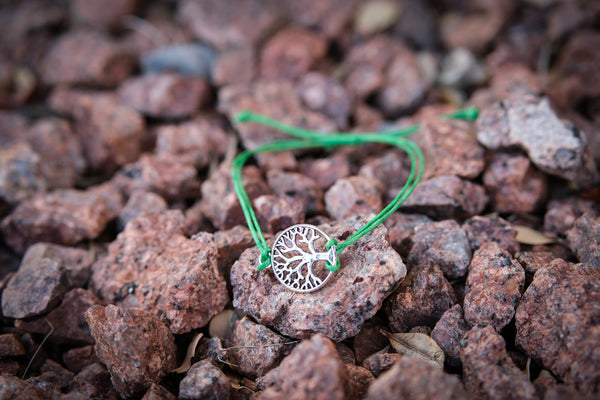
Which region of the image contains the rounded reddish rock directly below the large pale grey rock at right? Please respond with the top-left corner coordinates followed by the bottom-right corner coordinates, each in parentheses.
top-left (483, 153), bottom-right (547, 214)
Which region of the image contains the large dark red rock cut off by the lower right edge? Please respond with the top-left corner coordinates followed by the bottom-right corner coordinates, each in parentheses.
top-left (516, 260), bottom-right (600, 394)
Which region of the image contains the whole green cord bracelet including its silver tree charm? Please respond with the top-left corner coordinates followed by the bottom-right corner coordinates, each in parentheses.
top-left (231, 108), bottom-right (478, 292)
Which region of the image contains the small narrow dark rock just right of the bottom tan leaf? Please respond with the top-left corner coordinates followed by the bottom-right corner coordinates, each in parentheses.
top-left (431, 304), bottom-right (470, 367)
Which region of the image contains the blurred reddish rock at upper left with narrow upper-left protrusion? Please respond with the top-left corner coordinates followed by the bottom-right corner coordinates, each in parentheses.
top-left (49, 89), bottom-right (146, 174)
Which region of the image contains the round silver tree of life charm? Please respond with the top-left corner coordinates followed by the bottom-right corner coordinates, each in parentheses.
top-left (271, 224), bottom-right (337, 293)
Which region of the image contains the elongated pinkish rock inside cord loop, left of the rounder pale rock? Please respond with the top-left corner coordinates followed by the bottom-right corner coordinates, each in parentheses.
top-left (267, 169), bottom-right (325, 215)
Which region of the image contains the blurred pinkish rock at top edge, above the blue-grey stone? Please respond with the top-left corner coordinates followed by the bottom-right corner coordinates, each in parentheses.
top-left (177, 0), bottom-right (281, 49)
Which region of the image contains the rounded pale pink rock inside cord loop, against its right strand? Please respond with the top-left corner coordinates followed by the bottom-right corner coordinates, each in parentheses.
top-left (325, 175), bottom-right (381, 219)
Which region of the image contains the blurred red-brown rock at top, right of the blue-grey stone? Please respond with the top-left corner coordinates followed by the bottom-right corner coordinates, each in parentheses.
top-left (260, 26), bottom-right (327, 79)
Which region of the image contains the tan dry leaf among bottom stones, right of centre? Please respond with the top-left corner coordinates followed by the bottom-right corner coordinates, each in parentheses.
top-left (381, 330), bottom-right (445, 369)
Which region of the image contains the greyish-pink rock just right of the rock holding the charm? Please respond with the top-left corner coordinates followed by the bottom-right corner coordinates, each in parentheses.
top-left (408, 220), bottom-right (471, 279)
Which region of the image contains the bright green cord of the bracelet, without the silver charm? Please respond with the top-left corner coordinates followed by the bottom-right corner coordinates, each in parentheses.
top-left (231, 107), bottom-right (478, 271)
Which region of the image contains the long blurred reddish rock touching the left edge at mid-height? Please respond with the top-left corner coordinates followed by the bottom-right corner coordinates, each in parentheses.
top-left (0, 185), bottom-right (122, 253)
